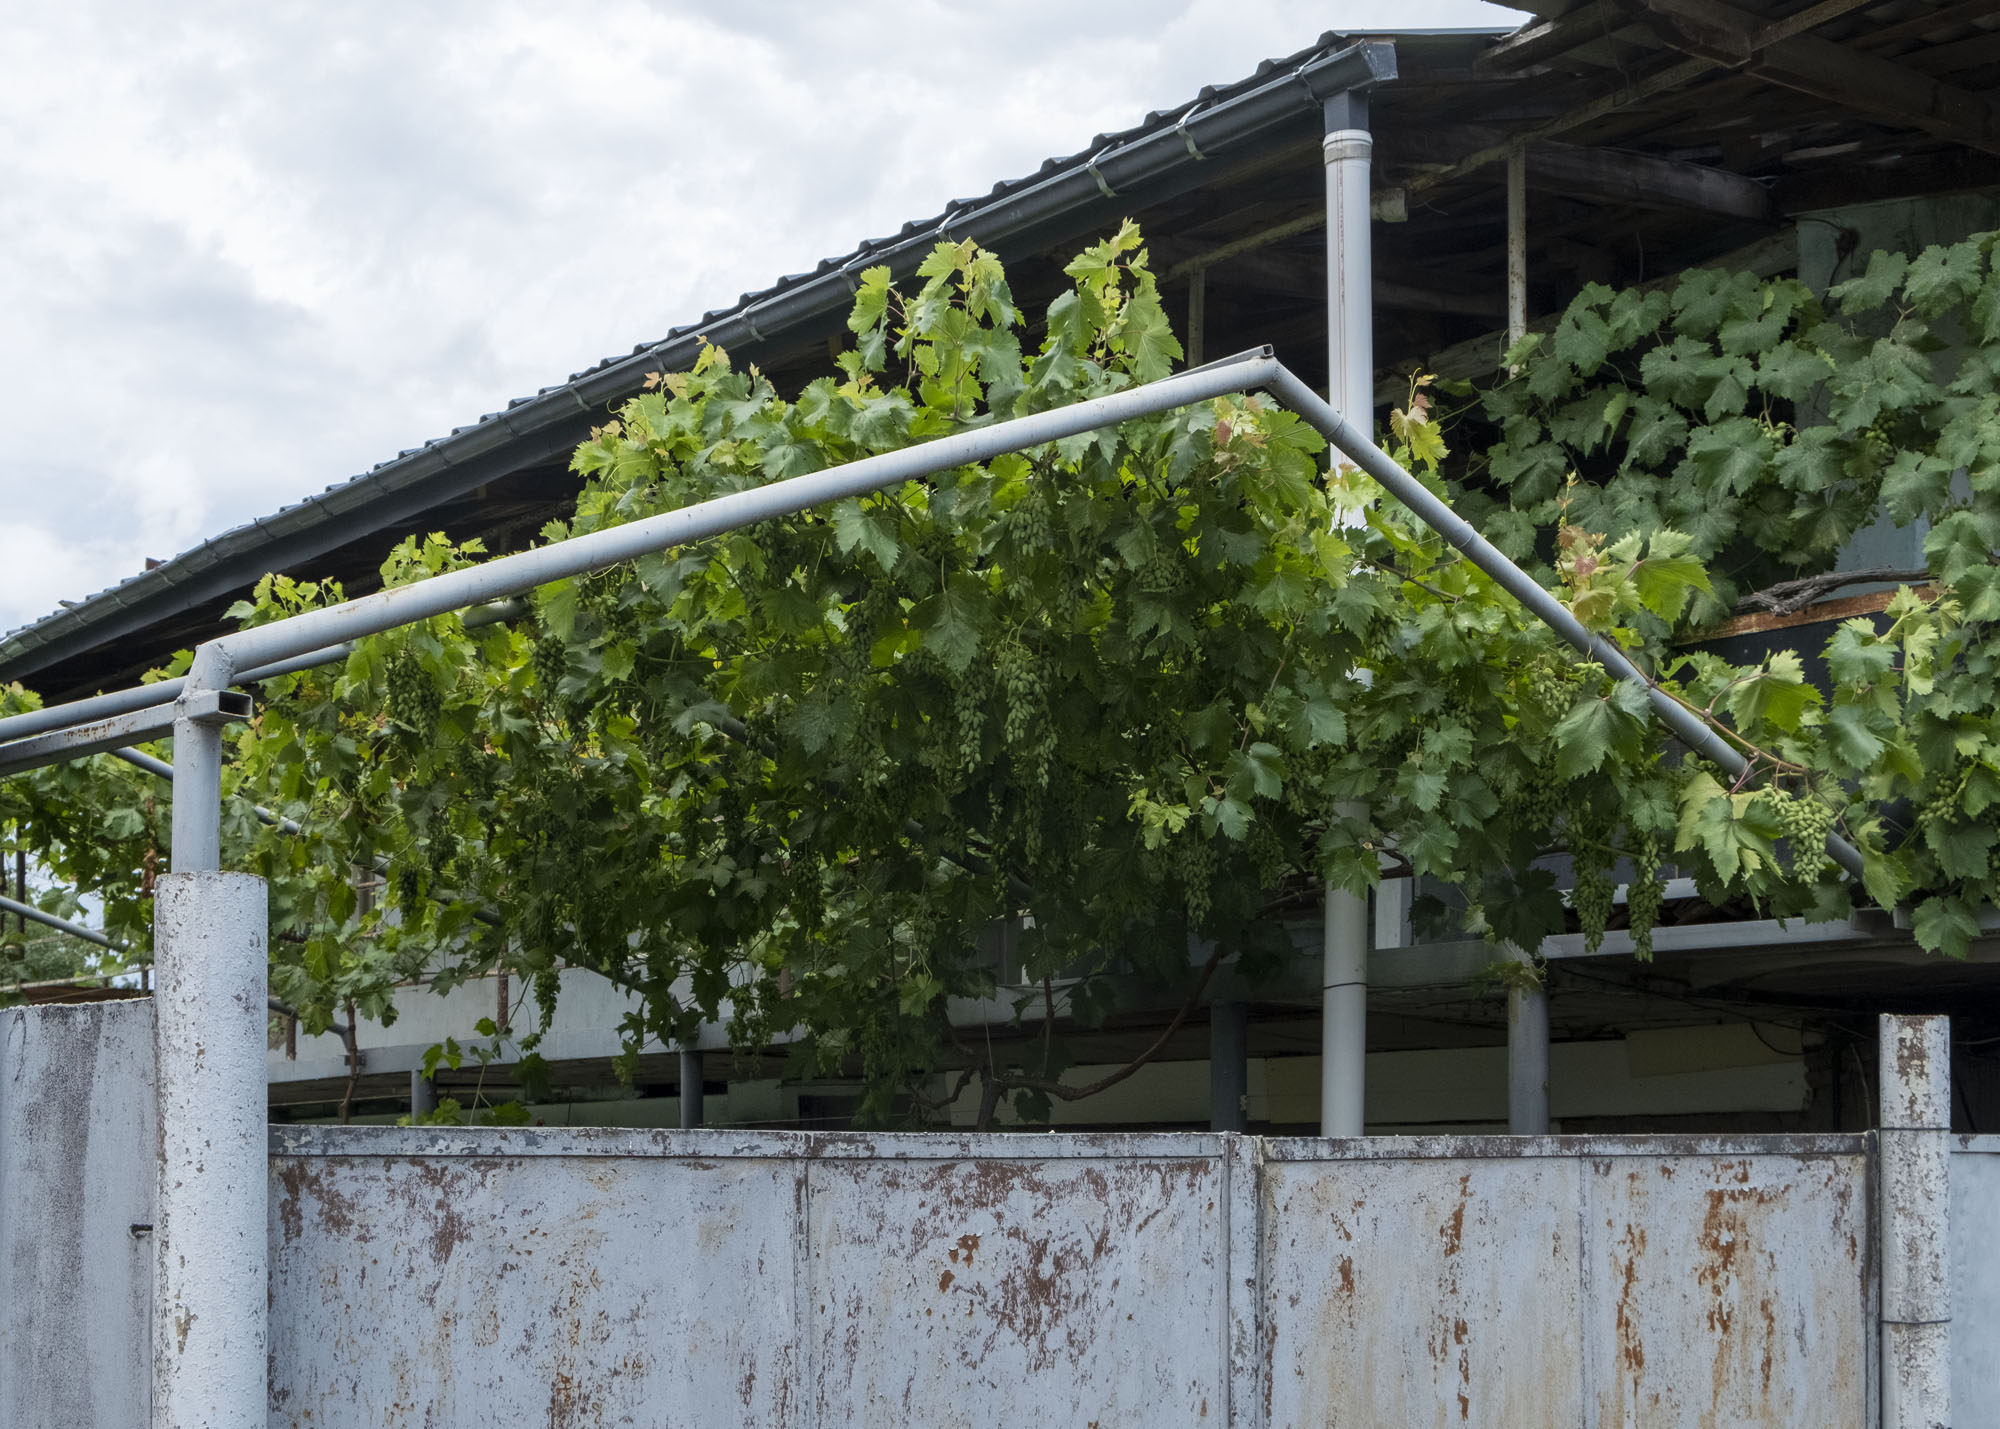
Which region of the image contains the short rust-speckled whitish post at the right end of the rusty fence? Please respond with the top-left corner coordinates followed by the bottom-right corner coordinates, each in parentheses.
top-left (1876, 1013), bottom-right (1952, 1429)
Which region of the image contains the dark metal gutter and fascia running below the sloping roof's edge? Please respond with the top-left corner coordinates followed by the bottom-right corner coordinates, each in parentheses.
top-left (0, 36), bottom-right (1396, 682)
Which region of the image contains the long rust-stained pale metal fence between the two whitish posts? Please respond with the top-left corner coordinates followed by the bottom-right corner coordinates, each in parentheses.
top-left (272, 1129), bottom-right (1874, 1425)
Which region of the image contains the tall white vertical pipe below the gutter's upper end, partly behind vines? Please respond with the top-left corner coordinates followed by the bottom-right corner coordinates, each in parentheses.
top-left (1320, 90), bottom-right (1374, 1137)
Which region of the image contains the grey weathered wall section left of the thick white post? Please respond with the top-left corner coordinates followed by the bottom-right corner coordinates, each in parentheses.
top-left (0, 999), bottom-right (158, 1429)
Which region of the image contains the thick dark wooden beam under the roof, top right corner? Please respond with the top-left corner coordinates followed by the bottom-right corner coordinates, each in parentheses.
top-left (1638, 0), bottom-right (2000, 154)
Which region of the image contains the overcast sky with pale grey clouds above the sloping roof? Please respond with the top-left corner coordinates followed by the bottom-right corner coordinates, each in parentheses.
top-left (0, 0), bottom-right (1518, 630)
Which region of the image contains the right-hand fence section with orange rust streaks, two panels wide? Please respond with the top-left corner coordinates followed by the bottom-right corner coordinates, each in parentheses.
top-left (1262, 1137), bottom-right (1874, 1425)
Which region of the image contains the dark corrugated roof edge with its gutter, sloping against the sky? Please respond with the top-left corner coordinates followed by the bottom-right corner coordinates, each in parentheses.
top-left (0, 26), bottom-right (1508, 680)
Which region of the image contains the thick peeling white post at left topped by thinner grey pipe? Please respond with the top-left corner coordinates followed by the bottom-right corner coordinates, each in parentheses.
top-left (152, 646), bottom-right (270, 1429)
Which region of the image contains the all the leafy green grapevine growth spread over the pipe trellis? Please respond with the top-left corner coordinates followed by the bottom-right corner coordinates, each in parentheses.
top-left (15, 226), bottom-right (2000, 1119)
